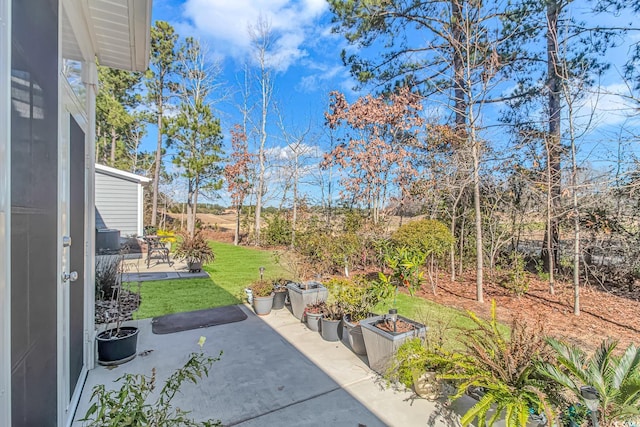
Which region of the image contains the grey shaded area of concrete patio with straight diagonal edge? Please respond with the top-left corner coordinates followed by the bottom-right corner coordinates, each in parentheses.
top-left (74, 306), bottom-right (392, 427)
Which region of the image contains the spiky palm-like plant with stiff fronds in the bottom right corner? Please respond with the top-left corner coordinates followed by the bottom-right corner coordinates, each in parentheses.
top-left (540, 338), bottom-right (640, 427)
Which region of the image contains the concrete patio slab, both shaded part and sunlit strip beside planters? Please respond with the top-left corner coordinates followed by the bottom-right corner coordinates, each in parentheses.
top-left (74, 305), bottom-right (459, 427)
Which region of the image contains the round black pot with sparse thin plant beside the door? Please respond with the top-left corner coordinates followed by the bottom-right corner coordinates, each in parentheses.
top-left (95, 255), bottom-right (140, 365)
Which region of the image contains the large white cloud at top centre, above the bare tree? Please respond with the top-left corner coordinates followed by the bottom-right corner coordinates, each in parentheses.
top-left (184, 0), bottom-right (327, 71)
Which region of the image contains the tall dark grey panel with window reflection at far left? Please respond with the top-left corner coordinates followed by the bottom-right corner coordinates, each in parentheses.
top-left (10, 0), bottom-right (59, 426)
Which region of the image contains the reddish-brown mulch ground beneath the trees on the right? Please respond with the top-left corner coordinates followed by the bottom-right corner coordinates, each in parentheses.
top-left (417, 276), bottom-right (640, 350)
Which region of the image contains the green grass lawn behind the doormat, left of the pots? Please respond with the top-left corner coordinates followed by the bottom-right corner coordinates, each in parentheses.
top-left (134, 241), bottom-right (287, 319)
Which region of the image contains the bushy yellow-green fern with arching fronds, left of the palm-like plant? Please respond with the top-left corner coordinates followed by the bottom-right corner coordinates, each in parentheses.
top-left (441, 301), bottom-right (559, 427)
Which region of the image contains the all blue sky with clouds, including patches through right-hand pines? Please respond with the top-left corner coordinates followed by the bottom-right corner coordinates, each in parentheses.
top-left (143, 0), bottom-right (638, 206)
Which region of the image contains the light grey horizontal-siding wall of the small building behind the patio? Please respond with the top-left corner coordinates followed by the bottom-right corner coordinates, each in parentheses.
top-left (95, 171), bottom-right (142, 237)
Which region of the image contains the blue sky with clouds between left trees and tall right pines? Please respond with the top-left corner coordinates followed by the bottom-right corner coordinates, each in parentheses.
top-left (148, 0), bottom-right (354, 205)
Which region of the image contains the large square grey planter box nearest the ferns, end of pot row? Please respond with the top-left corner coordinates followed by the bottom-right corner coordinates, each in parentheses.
top-left (360, 315), bottom-right (427, 374)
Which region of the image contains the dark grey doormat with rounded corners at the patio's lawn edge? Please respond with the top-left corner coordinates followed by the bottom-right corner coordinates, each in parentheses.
top-left (151, 305), bottom-right (247, 335)
